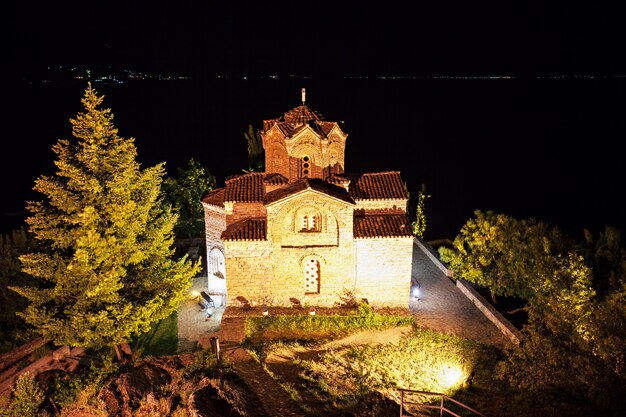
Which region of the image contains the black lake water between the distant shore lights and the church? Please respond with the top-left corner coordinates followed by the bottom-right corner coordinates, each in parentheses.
top-left (0, 78), bottom-right (626, 239)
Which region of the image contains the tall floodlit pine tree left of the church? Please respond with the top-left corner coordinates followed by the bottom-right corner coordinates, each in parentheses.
top-left (14, 84), bottom-right (198, 349)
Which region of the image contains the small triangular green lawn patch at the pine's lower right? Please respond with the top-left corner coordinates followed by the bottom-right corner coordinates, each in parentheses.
top-left (132, 311), bottom-right (178, 357)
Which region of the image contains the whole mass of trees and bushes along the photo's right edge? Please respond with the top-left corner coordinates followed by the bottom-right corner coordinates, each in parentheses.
top-left (441, 211), bottom-right (626, 410)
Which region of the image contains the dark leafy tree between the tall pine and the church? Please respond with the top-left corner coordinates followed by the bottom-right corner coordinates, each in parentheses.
top-left (163, 158), bottom-right (216, 238)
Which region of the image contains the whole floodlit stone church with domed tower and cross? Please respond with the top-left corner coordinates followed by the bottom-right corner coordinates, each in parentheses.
top-left (202, 89), bottom-right (413, 307)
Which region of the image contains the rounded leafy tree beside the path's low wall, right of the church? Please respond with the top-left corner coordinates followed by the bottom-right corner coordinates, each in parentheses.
top-left (440, 211), bottom-right (589, 300)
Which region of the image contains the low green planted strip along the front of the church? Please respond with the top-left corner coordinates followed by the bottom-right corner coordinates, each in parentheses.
top-left (246, 312), bottom-right (415, 341)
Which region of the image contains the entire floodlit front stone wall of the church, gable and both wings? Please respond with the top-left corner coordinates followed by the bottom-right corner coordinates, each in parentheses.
top-left (225, 190), bottom-right (413, 307)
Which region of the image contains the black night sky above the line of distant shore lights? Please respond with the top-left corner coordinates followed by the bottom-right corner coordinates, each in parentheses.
top-left (9, 1), bottom-right (626, 77)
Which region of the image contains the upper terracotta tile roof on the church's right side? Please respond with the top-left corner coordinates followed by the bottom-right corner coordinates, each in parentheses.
top-left (343, 171), bottom-right (407, 200)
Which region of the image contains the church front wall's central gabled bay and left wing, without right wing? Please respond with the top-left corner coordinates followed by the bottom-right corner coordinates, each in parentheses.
top-left (226, 190), bottom-right (356, 306)
